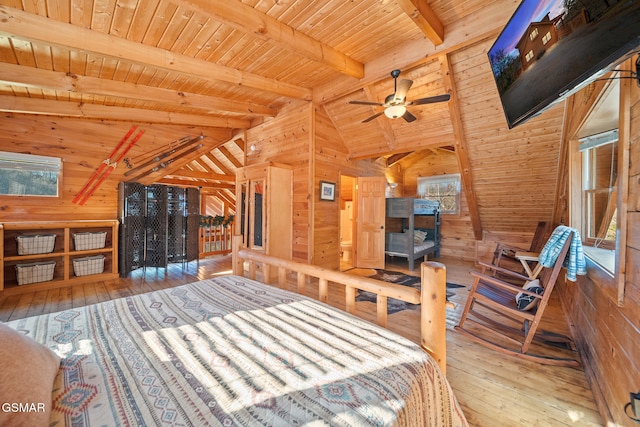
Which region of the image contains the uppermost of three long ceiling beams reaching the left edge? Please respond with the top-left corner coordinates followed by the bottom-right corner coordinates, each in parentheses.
top-left (0, 5), bottom-right (311, 100)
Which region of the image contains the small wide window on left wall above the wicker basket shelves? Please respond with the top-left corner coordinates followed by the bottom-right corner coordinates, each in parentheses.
top-left (0, 151), bottom-right (62, 197)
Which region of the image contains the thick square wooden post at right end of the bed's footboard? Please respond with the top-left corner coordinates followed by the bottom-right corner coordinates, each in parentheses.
top-left (420, 261), bottom-right (447, 375)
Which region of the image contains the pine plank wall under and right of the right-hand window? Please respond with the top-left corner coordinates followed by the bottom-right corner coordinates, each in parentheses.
top-left (557, 74), bottom-right (640, 425)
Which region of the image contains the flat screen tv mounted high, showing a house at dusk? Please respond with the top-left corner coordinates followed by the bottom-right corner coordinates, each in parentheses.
top-left (488, 0), bottom-right (640, 128)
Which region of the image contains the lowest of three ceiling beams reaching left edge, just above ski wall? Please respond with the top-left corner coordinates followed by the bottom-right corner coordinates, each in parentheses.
top-left (0, 95), bottom-right (251, 129)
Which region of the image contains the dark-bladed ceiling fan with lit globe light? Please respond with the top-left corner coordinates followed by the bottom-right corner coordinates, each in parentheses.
top-left (349, 70), bottom-right (451, 123)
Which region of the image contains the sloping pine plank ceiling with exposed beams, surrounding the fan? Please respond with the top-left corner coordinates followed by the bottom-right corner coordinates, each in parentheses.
top-left (0, 0), bottom-right (544, 236)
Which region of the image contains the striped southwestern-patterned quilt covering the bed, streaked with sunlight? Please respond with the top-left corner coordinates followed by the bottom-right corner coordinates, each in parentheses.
top-left (7, 276), bottom-right (467, 427)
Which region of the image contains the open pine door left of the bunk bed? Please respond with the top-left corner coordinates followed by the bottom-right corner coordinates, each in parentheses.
top-left (354, 176), bottom-right (387, 268)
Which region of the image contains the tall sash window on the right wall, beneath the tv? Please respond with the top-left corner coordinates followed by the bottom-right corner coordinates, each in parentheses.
top-left (579, 130), bottom-right (618, 249)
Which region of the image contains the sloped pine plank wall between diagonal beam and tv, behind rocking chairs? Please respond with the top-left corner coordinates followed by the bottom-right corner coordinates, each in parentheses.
top-left (450, 41), bottom-right (563, 233)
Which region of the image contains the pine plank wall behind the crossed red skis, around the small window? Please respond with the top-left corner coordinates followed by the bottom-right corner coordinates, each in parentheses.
top-left (0, 113), bottom-right (227, 221)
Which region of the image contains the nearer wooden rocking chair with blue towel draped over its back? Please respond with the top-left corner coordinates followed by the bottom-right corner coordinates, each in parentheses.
top-left (455, 231), bottom-right (580, 366)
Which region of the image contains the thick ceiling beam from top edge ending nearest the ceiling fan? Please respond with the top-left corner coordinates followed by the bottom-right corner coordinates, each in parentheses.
top-left (174, 0), bottom-right (364, 79)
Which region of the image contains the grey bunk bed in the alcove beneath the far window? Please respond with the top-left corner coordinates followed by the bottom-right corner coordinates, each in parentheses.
top-left (385, 197), bottom-right (440, 270)
